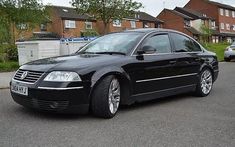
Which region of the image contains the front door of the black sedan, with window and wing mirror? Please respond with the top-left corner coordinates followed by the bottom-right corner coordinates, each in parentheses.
top-left (129, 33), bottom-right (176, 95)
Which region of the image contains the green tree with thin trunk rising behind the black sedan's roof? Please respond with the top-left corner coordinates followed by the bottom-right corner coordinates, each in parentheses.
top-left (72, 0), bottom-right (142, 34)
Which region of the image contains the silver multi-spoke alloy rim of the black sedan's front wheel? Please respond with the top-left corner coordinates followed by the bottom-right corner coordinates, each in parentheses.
top-left (109, 78), bottom-right (120, 114)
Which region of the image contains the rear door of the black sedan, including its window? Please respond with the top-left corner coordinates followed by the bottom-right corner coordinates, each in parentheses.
top-left (170, 32), bottom-right (202, 87)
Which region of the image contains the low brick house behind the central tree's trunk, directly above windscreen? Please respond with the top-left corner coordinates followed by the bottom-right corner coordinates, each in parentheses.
top-left (97, 12), bottom-right (163, 34)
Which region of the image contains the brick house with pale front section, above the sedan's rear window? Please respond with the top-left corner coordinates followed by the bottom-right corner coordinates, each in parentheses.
top-left (157, 7), bottom-right (216, 40)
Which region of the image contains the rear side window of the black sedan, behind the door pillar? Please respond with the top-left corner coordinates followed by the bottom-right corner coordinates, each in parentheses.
top-left (171, 33), bottom-right (201, 52)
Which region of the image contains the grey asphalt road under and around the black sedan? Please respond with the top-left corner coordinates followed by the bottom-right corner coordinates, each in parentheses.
top-left (0, 63), bottom-right (235, 147)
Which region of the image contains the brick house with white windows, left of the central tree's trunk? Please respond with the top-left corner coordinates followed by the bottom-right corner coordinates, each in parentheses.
top-left (50, 6), bottom-right (97, 37)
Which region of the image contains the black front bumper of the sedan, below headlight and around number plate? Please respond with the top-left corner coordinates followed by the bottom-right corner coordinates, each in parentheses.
top-left (10, 82), bottom-right (90, 114)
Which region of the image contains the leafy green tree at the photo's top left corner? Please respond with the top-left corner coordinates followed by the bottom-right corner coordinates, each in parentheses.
top-left (0, 0), bottom-right (47, 43)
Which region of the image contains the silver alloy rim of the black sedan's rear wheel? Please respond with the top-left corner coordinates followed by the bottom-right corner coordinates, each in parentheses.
top-left (201, 70), bottom-right (213, 95)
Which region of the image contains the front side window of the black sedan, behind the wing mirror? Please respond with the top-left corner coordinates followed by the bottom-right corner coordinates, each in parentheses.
top-left (142, 34), bottom-right (171, 54)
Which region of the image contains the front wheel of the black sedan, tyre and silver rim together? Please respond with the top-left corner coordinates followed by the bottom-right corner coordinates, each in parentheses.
top-left (91, 76), bottom-right (121, 118)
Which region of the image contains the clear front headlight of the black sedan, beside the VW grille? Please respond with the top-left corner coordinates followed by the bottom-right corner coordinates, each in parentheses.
top-left (44, 71), bottom-right (82, 82)
